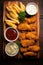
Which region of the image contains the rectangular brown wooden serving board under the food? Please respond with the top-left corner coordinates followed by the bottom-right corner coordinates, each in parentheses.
top-left (3, 0), bottom-right (40, 58)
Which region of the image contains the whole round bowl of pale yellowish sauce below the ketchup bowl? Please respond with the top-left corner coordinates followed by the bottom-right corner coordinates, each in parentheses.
top-left (5, 43), bottom-right (19, 57)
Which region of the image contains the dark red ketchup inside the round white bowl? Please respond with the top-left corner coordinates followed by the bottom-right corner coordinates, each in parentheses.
top-left (6, 28), bottom-right (17, 40)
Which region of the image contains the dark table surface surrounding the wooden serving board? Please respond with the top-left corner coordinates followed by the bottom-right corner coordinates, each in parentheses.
top-left (0, 0), bottom-right (43, 65)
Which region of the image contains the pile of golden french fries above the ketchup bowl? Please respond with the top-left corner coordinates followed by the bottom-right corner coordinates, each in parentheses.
top-left (5, 2), bottom-right (25, 28)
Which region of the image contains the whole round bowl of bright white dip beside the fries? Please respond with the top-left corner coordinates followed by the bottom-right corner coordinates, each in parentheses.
top-left (26, 2), bottom-right (38, 15)
